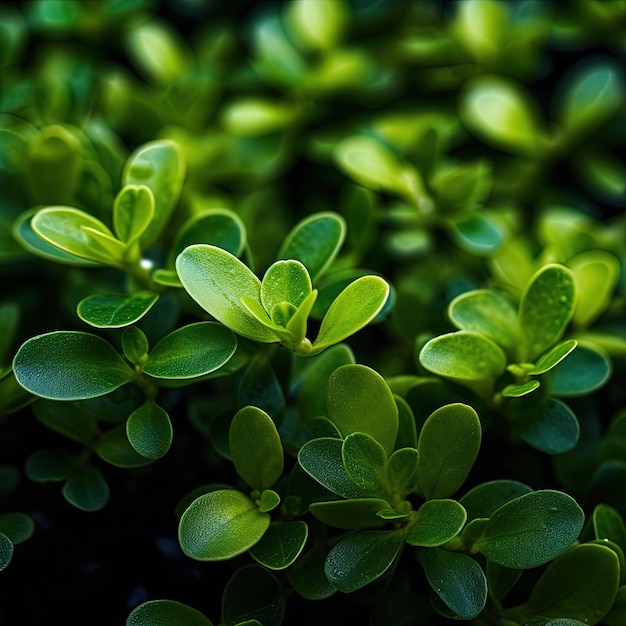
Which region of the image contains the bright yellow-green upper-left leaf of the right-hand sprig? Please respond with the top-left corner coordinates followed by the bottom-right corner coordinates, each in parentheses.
top-left (448, 289), bottom-right (521, 351)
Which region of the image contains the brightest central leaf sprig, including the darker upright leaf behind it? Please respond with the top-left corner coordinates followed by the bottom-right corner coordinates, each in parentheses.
top-left (176, 214), bottom-right (389, 355)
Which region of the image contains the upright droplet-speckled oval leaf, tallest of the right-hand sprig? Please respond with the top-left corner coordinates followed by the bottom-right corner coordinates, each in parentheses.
top-left (519, 264), bottom-right (576, 361)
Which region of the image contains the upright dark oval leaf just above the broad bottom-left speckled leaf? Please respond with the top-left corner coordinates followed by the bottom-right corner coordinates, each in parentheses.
top-left (228, 406), bottom-right (284, 491)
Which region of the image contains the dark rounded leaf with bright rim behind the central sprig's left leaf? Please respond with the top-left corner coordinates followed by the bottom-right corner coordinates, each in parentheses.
top-left (172, 208), bottom-right (246, 257)
